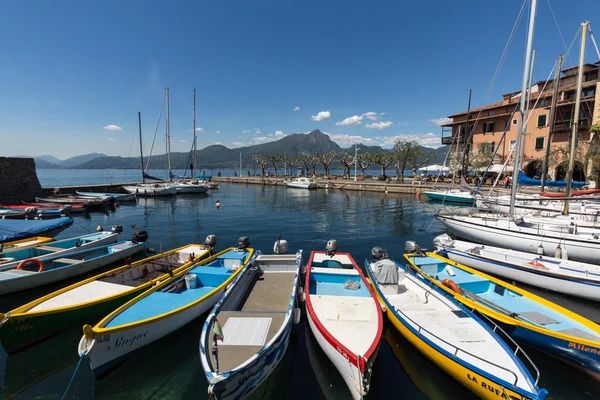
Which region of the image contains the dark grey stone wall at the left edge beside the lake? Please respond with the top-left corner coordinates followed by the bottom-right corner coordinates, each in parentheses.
top-left (0, 157), bottom-right (42, 201)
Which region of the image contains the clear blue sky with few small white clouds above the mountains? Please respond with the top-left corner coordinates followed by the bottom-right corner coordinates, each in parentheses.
top-left (0, 0), bottom-right (600, 158)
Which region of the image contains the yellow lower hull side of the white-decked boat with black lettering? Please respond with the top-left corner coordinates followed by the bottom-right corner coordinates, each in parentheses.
top-left (371, 282), bottom-right (523, 400)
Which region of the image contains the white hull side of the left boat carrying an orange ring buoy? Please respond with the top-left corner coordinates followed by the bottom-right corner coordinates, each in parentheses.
top-left (0, 243), bottom-right (144, 294)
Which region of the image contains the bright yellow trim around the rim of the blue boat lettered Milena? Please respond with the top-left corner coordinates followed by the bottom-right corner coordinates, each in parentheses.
top-left (404, 252), bottom-right (600, 347)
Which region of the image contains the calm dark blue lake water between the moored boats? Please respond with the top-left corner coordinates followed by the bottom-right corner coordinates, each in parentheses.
top-left (0, 182), bottom-right (600, 399)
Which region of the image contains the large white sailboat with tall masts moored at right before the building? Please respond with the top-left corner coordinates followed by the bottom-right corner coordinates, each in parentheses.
top-left (436, 16), bottom-right (600, 264)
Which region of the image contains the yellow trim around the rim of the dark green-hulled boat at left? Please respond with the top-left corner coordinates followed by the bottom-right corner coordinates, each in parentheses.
top-left (10, 244), bottom-right (210, 318)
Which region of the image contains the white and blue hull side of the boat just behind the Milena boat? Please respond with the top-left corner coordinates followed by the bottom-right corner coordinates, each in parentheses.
top-left (444, 248), bottom-right (600, 301)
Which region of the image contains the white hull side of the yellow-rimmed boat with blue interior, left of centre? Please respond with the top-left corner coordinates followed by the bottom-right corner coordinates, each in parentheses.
top-left (80, 288), bottom-right (225, 379)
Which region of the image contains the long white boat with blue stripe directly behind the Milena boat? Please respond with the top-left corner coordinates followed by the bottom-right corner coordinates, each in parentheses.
top-left (433, 234), bottom-right (600, 301)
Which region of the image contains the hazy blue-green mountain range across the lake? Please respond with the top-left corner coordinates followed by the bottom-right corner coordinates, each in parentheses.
top-left (19, 129), bottom-right (448, 169)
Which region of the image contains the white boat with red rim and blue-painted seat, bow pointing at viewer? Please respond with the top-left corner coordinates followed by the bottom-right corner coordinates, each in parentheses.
top-left (304, 240), bottom-right (383, 399)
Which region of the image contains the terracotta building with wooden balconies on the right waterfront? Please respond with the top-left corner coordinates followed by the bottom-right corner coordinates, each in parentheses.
top-left (442, 61), bottom-right (600, 180)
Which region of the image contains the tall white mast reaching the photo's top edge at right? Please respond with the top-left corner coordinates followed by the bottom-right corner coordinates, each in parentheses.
top-left (510, 0), bottom-right (537, 216)
